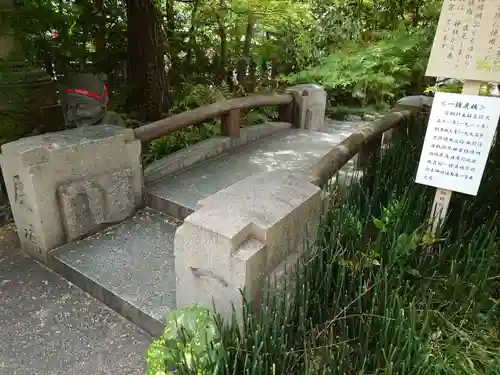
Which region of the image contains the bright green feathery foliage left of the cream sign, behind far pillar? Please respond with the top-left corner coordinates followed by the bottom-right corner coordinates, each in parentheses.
top-left (286, 30), bottom-right (432, 106)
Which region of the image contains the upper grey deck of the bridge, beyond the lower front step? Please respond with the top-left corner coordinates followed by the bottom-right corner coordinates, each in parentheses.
top-left (146, 125), bottom-right (359, 220)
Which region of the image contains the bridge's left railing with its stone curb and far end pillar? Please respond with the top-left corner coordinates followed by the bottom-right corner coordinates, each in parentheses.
top-left (142, 84), bottom-right (326, 184)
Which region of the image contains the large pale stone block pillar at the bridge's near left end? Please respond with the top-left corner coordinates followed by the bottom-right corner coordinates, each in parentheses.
top-left (1, 125), bottom-right (143, 262)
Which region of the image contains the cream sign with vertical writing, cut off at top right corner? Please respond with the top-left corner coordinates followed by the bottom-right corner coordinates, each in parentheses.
top-left (426, 0), bottom-right (500, 82)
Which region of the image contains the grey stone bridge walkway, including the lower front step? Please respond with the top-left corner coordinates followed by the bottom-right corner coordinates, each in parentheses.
top-left (47, 121), bottom-right (363, 334)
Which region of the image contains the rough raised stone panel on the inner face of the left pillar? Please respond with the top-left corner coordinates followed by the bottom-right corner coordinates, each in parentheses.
top-left (58, 168), bottom-right (136, 240)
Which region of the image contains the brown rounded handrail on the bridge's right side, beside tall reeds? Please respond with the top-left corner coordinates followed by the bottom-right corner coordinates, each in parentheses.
top-left (310, 110), bottom-right (412, 186)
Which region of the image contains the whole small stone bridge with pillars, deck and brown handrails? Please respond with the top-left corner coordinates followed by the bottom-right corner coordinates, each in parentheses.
top-left (1, 85), bottom-right (430, 335)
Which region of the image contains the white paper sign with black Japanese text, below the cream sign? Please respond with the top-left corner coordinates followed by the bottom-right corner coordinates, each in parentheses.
top-left (415, 92), bottom-right (500, 195)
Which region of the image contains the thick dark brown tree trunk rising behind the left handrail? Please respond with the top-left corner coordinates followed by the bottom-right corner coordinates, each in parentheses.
top-left (127, 0), bottom-right (165, 121)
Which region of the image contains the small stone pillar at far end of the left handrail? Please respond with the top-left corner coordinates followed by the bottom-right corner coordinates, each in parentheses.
top-left (286, 84), bottom-right (326, 131)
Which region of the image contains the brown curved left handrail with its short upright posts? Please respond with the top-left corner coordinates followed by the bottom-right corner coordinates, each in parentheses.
top-left (134, 93), bottom-right (294, 142)
